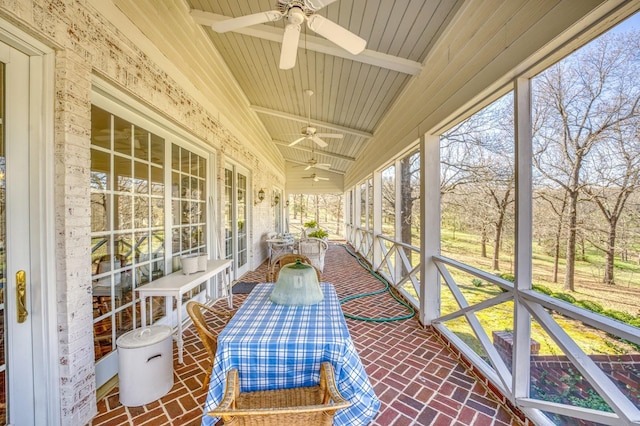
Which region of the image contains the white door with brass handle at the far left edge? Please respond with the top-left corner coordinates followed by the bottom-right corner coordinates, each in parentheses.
top-left (0, 39), bottom-right (37, 425)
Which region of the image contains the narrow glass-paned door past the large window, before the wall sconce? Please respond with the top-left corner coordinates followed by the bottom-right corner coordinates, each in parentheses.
top-left (224, 165), bottom-right (249, 279)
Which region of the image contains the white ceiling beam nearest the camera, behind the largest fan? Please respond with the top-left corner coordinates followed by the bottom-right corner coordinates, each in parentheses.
top-left (191, 9), bottom-right (422, 75)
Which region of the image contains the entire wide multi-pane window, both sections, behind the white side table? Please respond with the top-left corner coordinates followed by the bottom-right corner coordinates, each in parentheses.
top-left (91, 106), bottom-right (207, 361)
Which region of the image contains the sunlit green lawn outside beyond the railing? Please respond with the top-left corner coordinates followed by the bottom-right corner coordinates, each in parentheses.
top-left (441, 230), bottom-right (640, 355)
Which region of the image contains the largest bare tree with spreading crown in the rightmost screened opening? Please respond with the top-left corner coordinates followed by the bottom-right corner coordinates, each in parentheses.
top-left (533, 32), bottom-right (640, 291)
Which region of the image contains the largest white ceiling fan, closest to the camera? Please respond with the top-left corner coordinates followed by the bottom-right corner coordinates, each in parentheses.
top-left (211, 0), bottom-right (367, 70)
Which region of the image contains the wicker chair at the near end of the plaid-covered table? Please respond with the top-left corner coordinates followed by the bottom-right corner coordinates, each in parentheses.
top-left (207, 362), bottom-right (351, 426)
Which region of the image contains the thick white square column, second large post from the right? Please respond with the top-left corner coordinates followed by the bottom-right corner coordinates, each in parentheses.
top-left (420, 135), bottom-right (440, 325)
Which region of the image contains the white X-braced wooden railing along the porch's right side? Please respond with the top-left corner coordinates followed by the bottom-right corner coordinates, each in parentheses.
top-left (348, 229), bottom-right (640, 425)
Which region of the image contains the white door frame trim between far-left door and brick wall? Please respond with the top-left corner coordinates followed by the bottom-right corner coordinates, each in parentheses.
top-left (0, 19), bottom-right (61, 426)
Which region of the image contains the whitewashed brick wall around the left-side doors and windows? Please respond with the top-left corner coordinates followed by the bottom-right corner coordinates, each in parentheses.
top-left (0, 0), bottom-right (284, 425)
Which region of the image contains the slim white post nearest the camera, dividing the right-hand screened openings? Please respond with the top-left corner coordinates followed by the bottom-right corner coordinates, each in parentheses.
top-left (512, 78), bottom-right (533, 398)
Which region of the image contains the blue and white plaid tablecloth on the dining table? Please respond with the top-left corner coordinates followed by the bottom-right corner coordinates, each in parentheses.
top-left (202, 283), bottom-right (380, 426)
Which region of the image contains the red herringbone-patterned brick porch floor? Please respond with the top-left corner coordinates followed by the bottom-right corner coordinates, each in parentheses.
top-left (91, 243), bottom-right (522, 426)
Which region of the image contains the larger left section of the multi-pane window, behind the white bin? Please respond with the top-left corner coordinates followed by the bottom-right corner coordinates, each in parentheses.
top-left (91, 106), bottom-right (165, 360)
